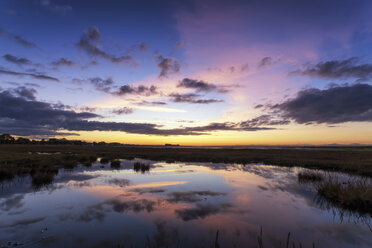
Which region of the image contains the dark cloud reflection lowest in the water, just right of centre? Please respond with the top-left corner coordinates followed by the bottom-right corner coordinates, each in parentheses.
top-left (175, 203), bottom-right (231, 221)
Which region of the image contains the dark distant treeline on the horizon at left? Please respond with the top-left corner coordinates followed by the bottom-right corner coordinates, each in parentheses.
top-left (0, 134), bottom-right (122, 146)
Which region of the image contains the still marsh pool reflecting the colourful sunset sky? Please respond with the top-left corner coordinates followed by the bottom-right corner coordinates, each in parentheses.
top-left (0, 159), bottom-right (372, 248)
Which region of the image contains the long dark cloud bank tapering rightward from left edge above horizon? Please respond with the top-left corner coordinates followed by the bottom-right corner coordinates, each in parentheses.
top-left (0, 91), bottom-right (278, 136)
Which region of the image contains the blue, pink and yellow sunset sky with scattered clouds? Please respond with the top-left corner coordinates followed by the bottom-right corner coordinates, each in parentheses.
top-left (0, 0), bottom-right (372, 145)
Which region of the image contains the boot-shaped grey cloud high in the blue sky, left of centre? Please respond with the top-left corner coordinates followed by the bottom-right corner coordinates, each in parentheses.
top-left (77, 26), bottom-right (135, 64)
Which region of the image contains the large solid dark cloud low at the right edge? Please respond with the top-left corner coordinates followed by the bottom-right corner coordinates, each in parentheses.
top-left (271, 84), bottom-right (372, 124)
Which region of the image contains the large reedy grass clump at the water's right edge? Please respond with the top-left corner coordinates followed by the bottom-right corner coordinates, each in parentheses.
top-left (317, 177), bottom-right (372, 215)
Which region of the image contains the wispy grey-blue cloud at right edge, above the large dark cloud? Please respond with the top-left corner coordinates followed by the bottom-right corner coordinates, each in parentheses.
top-left (290, 57), bottom-right (372, 81)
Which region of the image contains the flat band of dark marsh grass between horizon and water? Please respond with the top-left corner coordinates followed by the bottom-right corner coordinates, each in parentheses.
top-left (0, 144), bottom-right (372, 181)
